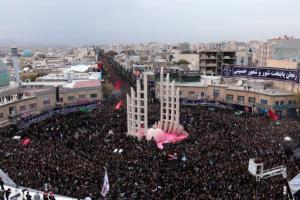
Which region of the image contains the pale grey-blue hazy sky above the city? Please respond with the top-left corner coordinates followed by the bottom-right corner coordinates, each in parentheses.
top-left (0, 0), bottom-right (300, 44)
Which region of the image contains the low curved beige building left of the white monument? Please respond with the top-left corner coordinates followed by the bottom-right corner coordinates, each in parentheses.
top-left (0, 81), bottom-right (102, 127)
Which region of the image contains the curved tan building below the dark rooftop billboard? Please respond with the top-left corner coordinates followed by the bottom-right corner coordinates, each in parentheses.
top-left (156, 83), bottom-right (298, 117)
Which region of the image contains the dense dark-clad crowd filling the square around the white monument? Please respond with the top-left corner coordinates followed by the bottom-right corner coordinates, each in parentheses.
top-left (0, 55), bottom-right (300, 200)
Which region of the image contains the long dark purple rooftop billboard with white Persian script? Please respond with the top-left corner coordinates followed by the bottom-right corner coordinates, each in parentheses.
top-left (222, 65), bottom-right (299, 82)
